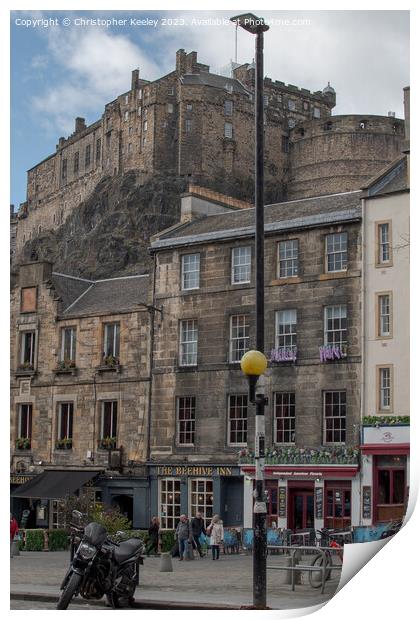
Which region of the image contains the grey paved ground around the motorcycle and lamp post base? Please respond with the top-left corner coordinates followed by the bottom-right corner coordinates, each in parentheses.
top-left (10, 551), bottom-right (340, 610)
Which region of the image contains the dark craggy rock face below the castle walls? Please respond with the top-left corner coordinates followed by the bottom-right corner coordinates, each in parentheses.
top-left (23, 171), bottom-right (187, 279)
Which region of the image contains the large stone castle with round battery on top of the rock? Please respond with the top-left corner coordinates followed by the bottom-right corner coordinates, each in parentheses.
top-left (17, 49), bottom-right (404, 253)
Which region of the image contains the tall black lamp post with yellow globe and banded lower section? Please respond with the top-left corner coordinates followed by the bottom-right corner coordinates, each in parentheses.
top-left (231, 13), bottom-right (269, 609)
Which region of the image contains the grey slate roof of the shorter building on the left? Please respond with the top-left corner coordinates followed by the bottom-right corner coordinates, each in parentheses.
top-left (52, 273), bottom-right (150, 318)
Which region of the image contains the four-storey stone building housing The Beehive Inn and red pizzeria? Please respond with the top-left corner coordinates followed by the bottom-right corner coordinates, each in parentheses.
top-left (149, 191), bottom-right (361, 529)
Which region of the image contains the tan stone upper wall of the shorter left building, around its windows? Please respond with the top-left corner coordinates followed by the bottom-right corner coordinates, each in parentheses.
top-left (10, 262), bottom-right (150, 524)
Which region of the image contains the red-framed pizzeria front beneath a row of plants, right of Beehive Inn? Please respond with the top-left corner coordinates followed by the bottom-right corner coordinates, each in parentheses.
top-left (241, 464), bottom-right (360, 532)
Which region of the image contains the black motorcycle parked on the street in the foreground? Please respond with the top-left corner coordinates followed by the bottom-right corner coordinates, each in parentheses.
top-left (57, 510), bottom-right (144, 609)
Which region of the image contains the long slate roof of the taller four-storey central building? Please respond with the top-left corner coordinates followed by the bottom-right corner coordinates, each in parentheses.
top-left (151, 191), bottom-right (361, 249)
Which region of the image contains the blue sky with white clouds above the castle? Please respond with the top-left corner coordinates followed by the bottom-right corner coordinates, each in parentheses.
top-left (10, 10), bottom-right (410, 208)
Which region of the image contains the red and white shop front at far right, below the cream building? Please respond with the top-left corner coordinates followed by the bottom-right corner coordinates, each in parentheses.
top-left (361, 423), bottom-right (410, 525)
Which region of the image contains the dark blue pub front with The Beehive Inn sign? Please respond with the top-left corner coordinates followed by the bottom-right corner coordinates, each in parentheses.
top-left (149, 464), bottom-right (243, 529)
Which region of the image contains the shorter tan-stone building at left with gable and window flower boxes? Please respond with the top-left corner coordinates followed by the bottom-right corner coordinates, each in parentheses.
top-left (10, 262), bottom-right (151, 527)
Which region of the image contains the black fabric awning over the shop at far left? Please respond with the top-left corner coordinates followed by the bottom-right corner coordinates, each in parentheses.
top-left (11, 469), bottom-right (100, 499)
